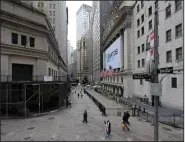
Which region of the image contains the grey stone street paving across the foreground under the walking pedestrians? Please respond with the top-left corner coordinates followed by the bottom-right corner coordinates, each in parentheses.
top-left (1, 87), bottom-right (183, 141)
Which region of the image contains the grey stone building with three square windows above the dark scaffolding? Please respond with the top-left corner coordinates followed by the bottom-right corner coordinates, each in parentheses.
top-left (1, 1), bottom-right (67, 81)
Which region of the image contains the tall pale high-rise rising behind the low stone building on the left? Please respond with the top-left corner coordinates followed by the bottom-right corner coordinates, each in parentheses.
top-left (24, 0), bottom-right (68, 65)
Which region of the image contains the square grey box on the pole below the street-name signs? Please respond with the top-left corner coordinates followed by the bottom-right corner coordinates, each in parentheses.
top-left (150, 83), bottom-right (162, 96)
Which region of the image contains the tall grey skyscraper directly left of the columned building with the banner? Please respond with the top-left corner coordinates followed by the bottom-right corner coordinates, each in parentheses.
top-left (92, 1), bottom-right (112, 82)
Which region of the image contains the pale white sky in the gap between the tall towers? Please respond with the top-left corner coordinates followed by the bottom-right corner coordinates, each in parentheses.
top-left (66, 1), bottom-right (92, 49)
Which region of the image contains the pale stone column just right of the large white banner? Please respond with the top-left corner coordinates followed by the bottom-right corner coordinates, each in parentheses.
top-left (120, 31), bottom-right (124, 69)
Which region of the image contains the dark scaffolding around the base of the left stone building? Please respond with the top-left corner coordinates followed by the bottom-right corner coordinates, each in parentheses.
top-left (0, 81), bottom-right (69, 118)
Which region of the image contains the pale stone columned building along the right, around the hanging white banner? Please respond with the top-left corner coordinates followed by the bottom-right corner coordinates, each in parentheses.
top-left (102, 1), bottom-right (184, 109)
